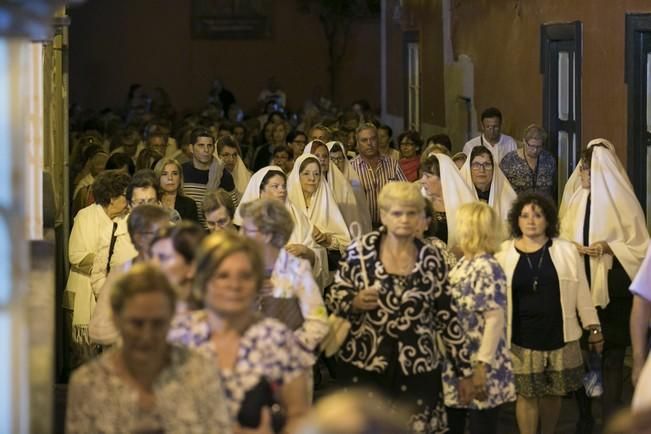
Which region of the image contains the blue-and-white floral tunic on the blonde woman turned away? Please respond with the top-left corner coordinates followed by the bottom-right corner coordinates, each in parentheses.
top-left (443, 254), bottom-right (516, 409)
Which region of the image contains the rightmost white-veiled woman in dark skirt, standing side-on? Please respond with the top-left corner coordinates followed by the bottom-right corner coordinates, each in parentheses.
top-left (560, 139), bottom-right (649, 424)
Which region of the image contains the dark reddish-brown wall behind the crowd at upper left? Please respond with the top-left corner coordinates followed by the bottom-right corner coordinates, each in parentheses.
top-left (70, 0), bottom-right (380, 114)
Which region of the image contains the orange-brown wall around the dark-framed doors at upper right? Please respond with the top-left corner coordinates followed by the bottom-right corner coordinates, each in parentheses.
top-left (452, 0), bottom-right (651, 161)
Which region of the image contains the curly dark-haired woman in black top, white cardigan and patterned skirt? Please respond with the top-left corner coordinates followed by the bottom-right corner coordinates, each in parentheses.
top-left (497, 193), bottom-right (603, 434)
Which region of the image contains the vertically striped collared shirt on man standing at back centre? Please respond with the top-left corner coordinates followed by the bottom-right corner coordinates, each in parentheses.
top-left (350, 155), bottom-right (407, 228)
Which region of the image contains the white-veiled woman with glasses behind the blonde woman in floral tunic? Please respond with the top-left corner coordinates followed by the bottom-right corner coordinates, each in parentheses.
top-left (460, 146), bottom-right (517, 221)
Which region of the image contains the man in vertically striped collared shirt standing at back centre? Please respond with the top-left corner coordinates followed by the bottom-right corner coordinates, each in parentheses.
top-left (350, 123), bottom-right (407, 229)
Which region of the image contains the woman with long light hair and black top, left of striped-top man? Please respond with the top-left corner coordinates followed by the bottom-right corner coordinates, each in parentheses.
top-left (154, 158), bottom-right (199, 223)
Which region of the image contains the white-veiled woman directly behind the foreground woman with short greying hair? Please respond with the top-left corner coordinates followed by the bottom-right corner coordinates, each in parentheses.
top-left (233, 166), bottom-right (328, 287)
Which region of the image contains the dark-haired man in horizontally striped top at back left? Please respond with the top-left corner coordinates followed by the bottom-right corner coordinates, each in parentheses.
top-left (181, 127), bottom-right (235, 228)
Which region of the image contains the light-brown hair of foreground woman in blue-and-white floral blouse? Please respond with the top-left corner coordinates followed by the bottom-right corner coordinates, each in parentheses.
top-left (192, 231), bottom-right (264, 302)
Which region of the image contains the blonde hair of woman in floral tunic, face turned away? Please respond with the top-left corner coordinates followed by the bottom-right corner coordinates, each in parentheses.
top-left (456, 201), bottom-right (503, 254)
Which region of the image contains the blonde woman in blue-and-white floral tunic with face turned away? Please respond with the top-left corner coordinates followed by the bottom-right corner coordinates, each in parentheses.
top-left (443, 201), bottom-right (515, 434)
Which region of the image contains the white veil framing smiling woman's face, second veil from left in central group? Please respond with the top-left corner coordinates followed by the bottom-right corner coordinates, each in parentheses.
top-left (287, 154), bottom-right (350, 248)
